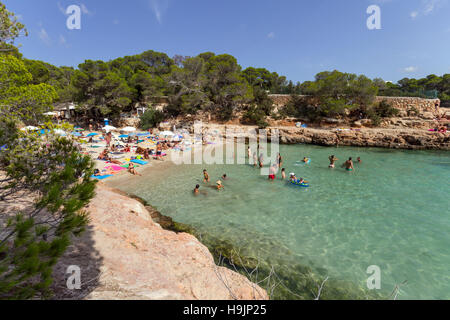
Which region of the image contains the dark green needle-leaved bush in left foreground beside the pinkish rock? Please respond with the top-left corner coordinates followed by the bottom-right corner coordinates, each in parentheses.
top-left (0, 131), bottom-right (95, 299)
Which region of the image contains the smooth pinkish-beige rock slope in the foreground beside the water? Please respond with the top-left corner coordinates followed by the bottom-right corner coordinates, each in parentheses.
top-left (53, 183), bottom-right (267, 300)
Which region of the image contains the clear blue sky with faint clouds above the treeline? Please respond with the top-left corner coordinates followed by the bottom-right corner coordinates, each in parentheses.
top-left (2, 0), bottom-right (450, 81)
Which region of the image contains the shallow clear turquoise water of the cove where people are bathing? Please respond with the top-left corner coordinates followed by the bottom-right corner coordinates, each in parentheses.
top-left (113, 145), bottom-right (450, 299)
